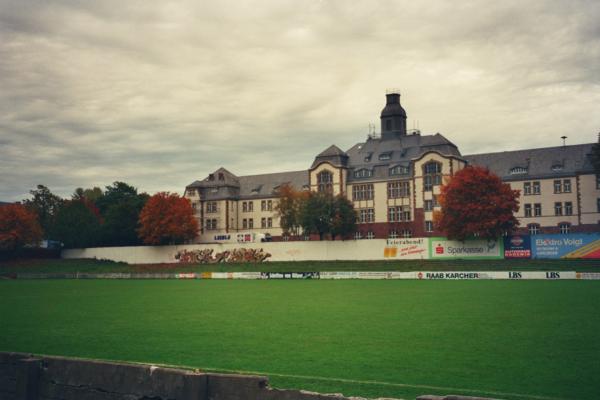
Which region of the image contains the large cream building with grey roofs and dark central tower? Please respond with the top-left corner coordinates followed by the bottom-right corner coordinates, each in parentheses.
top-left (185, 93), bottom-right (600, 242)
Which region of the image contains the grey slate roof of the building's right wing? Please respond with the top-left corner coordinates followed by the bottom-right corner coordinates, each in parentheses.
top-left (464, 143), bottom-right (594, 181)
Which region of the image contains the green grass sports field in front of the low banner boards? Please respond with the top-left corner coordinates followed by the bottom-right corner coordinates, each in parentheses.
top-left (0, 280), bottom-right (600, 400)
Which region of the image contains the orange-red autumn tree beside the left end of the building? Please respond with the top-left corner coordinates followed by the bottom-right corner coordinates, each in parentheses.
top-left (138, 192), bottom-right (198, 245)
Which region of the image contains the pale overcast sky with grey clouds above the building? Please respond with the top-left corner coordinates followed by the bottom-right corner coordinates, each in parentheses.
top-left (0, 0), bottom-right (600, 201)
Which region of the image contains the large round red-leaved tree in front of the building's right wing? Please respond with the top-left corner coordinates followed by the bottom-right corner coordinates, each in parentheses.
top-left (434, 166), bottom-right (519, 240)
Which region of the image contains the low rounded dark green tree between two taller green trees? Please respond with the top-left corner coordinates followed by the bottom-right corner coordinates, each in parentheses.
top-left (51, 200), bottom-right (102, 248)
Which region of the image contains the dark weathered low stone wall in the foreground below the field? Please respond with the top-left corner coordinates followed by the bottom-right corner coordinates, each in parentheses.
top-left (0, 353), bottom-right (502, 400)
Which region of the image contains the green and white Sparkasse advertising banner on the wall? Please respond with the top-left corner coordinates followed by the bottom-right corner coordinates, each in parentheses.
top-left (429, 238), bottom-right (504, 259)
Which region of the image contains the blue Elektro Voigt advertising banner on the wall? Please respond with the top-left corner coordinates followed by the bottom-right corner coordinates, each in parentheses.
top-left (531, 233), bottom-right (600, 259)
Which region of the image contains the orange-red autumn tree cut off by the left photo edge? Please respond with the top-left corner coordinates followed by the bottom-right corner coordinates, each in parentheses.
top-left (0, 204), bottom-right (42, 251)
